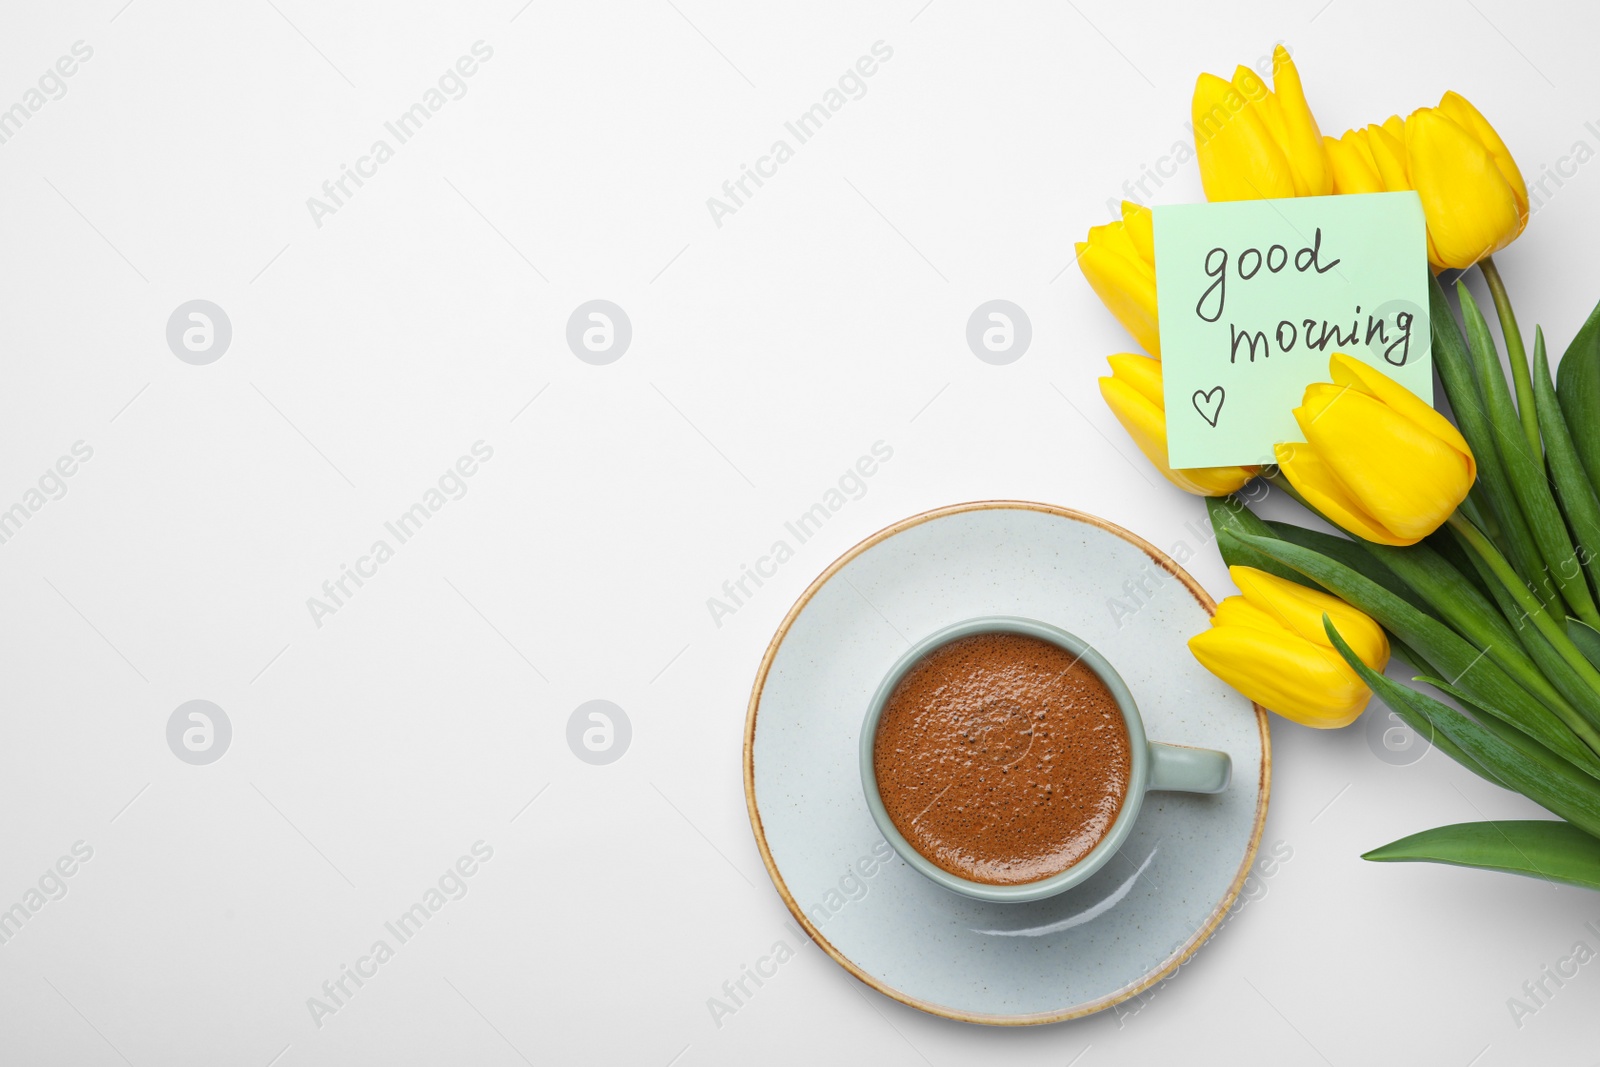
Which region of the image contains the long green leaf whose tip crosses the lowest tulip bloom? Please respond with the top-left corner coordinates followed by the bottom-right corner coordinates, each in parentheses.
top-left (1323, 616), bottom-right (1600, 833)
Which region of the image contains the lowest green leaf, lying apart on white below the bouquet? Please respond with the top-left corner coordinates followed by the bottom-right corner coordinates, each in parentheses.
top-left (1362, 819), bottom-right (1600, 889)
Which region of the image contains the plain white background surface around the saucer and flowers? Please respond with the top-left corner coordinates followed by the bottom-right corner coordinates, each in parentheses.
top-left (0, 0), bottom-right (1600, 1067)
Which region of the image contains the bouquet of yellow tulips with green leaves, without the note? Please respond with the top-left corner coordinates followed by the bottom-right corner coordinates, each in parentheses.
top-left (1078, 46), bottom-right (1600, 889)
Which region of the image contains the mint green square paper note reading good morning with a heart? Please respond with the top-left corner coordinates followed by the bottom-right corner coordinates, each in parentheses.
top-left (1155, 192), bottom-right (1434, 467)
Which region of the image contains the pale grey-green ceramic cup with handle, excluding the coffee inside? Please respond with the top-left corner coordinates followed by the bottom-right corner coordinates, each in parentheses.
top-left (861, 616), bottom-right (1234, 902)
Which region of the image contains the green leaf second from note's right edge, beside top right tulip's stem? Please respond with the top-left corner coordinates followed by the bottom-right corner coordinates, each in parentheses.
top-left (1456, 282), bottom-right (1600, 625)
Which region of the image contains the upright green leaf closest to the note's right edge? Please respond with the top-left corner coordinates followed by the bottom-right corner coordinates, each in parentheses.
top-left (1427, 275), bottom-right (1542, 581)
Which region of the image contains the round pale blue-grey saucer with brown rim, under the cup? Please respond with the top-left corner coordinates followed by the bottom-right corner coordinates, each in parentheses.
top-left (744, 501), bottom-right (1272, 1025)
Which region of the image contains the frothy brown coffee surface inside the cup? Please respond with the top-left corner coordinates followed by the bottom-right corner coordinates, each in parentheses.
top-left (872, 632), bottom-right (1133, 885)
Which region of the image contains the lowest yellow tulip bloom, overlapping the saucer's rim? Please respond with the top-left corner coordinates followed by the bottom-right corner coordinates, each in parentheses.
top-left (1189, 566), bottom-right (1389, 729)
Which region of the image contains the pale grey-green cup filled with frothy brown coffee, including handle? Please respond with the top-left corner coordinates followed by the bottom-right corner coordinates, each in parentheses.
top-left (861, 616), bottom-right (1232, 902)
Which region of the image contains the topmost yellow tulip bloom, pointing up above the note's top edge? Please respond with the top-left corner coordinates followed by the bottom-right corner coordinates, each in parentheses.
top-left (1190, 45), bottom-right (1333, 200)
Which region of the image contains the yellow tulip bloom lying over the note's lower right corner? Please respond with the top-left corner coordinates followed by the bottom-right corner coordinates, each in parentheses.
top-left (1275, 352), bottom-right (1478, 544)
